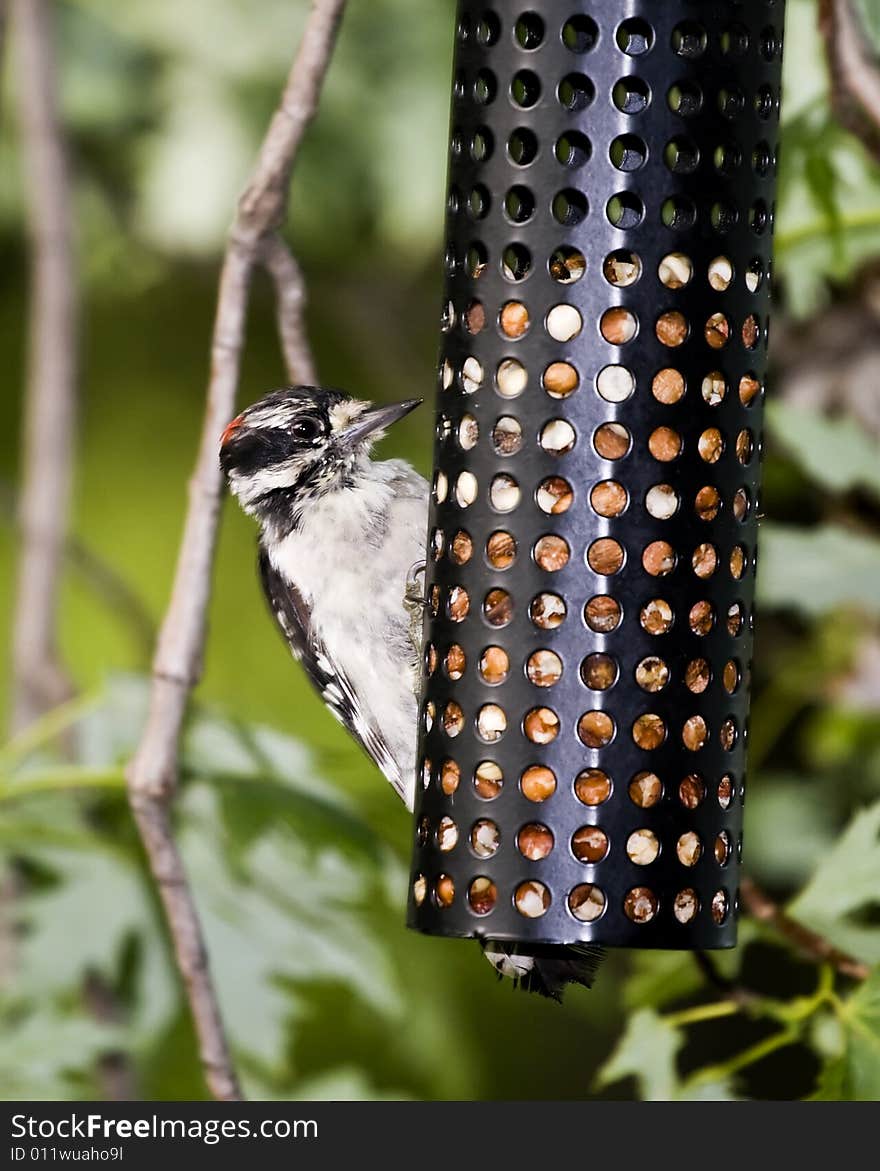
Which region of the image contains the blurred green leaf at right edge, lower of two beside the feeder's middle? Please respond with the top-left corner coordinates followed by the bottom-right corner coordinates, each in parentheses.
top-left (757, 521), bottom-right (880, 617)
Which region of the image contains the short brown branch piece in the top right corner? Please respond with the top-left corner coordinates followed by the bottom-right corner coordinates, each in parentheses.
top-left (819, 0), bottom-right (880, 159)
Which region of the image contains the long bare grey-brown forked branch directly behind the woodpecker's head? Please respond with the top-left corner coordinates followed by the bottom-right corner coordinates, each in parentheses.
top-left (128, 0), bottom-right (345, 1100)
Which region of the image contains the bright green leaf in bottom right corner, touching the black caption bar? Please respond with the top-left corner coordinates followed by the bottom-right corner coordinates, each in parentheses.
top-left (812, 968), bottom-right (880, 1102)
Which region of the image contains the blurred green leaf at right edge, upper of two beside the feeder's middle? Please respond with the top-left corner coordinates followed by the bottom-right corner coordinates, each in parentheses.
top-left (766, 402), bottom-right (880, 497)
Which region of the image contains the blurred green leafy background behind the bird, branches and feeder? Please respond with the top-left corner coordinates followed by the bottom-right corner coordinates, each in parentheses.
top-left (0, 0), bottom-right (880, 1100)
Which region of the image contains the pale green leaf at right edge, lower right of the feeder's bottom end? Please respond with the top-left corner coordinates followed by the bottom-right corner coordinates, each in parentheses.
top-left (789, 801), bottom-right (880, 964)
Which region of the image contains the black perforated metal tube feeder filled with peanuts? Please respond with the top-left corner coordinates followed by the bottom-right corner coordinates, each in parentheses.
top-left (409, 0), bottom-right (783, 949)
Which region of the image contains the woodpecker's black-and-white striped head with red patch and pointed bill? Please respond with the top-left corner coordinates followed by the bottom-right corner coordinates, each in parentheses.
top-left (220, 386), bottom-right (421, 523)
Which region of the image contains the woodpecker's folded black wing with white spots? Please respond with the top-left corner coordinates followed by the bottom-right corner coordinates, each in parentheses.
top-left (254, 548), bottom-right (407, 801)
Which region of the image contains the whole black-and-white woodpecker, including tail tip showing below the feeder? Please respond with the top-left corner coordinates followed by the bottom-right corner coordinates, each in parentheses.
top-left (220, 386), bottom-right (596, 999)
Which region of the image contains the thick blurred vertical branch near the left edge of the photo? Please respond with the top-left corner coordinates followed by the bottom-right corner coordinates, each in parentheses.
top-left (12, 0), bottom-right (77, 731)
